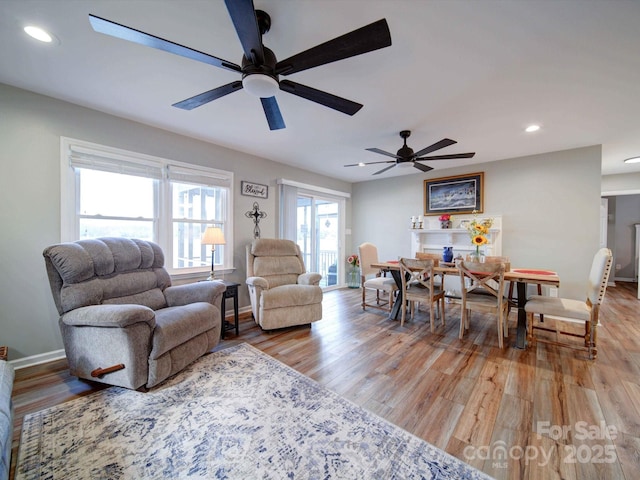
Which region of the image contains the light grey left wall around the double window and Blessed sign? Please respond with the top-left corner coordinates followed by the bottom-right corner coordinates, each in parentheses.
top-left (0, 84), bottom-right (351, 360)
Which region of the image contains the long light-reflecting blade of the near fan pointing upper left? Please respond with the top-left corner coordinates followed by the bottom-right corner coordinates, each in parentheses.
top-left (89, 14), bottom-right (242, 72)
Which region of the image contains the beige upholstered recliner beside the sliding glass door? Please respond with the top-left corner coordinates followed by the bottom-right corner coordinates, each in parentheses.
top-left (246, 238), bottom-right (322, 330)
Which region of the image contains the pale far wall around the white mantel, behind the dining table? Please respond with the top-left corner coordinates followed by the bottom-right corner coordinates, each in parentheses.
top-left (351, 146), bottom-right (601, 299)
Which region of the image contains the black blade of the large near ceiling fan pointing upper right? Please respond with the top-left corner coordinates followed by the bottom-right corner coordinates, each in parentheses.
top-left (278, 18), bottom-right (391, 75)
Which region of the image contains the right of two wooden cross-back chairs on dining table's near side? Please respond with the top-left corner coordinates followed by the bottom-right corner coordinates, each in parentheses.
top-left (458, 261), bottom-right (509, 348)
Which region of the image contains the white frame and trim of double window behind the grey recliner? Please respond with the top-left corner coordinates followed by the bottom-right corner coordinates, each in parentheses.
top-left (60, 137), bottom-right (234, 278)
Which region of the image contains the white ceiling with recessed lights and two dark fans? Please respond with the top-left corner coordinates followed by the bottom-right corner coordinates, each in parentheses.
top-left (0, 0), bottom-right (640, 182)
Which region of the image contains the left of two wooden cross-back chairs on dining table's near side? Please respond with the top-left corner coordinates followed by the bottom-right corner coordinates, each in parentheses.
top-left (399, 258), bottom-right (445, 332)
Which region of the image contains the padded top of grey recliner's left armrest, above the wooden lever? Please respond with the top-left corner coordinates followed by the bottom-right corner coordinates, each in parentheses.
top-left (61, 304), bottom-right (156, 328)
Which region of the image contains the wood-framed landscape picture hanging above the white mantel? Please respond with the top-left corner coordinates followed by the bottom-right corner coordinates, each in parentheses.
top-left (424, 172), bottom-right (484, 215)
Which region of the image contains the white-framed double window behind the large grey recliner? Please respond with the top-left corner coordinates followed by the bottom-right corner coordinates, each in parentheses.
top-left (61, 138), bottom-right (233, 275)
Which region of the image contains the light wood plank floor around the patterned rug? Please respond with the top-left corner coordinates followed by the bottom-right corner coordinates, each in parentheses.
top-left (13, 282), bottom-right (640, 480)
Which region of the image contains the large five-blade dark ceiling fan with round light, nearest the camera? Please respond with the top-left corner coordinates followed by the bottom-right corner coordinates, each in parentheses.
top-left (89, 0), bottom-right (391, 130)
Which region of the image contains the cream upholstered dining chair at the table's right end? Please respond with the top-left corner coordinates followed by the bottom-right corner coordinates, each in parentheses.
top-left (524, 248), bottom-right (613, 360)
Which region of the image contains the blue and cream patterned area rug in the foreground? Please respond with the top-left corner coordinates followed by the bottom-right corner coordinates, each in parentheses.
top-left (16, 344), bottom-right (489, 480)
